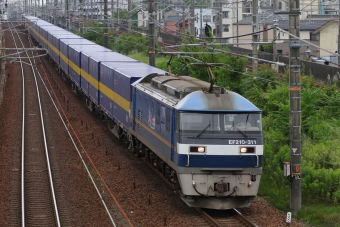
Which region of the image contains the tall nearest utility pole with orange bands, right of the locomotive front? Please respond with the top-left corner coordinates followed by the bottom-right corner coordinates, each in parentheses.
top-left (288, 0), bottom-right (302, 214)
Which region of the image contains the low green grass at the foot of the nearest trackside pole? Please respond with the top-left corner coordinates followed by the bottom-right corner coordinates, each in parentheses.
top-left (259, 177), bottom-right (340, 227)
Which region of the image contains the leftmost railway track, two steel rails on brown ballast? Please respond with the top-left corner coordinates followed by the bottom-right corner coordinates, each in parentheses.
top-left (7, 22), bottom-right (61, 226)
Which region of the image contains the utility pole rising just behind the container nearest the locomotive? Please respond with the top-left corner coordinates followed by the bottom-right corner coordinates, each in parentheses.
top-left (149, 0), bottom-right (156, 66)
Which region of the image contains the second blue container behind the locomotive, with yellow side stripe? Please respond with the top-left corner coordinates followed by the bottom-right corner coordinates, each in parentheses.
top-left (81, 50), bottom-right (138, 105)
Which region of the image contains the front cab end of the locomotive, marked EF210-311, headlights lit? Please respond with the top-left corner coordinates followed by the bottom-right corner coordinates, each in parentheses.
top-left (174, 91), bottom-right (263, 209)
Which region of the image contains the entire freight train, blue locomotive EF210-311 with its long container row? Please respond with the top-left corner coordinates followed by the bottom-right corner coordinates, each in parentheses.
top-left (22, 15), bottom-right (263, 209)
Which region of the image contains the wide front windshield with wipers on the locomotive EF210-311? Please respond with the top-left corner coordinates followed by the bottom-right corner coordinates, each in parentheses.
top-left (179, 112), bottom-right (262, 137)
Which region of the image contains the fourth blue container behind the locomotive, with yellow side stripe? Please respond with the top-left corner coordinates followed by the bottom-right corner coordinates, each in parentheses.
top-left (59, 37), bottom-right (98, 75)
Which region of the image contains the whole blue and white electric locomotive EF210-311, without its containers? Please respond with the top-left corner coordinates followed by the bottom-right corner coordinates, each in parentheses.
top-left (129, 75), bottom-right (263, 209)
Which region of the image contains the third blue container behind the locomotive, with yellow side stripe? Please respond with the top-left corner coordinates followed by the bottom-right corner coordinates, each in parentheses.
top-left (67, 44), bottom-right (108, 89)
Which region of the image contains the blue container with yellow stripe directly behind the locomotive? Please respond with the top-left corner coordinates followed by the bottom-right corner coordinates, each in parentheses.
top-left (99, 61), bottom-right (166, 130)
